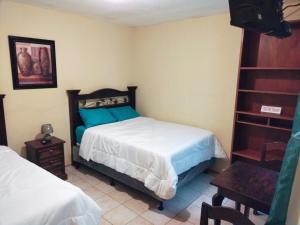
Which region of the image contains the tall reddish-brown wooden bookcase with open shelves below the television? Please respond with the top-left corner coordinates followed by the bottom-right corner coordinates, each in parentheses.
top-left (231, 21), bottom-right (300, 171)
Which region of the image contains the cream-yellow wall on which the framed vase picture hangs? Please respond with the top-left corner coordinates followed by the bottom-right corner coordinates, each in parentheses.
top-left (0, 1), bottom-right (132, 164)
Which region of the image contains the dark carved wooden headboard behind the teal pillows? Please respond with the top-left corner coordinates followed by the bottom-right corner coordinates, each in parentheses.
top-left (67, 86), bottom-right (137, 146)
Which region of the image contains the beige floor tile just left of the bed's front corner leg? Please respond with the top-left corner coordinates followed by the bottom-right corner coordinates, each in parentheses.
top-left (123, 196), bottom-right (157, 215)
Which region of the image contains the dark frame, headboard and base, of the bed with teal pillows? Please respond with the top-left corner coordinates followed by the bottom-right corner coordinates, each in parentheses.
top-left (67, 86), bottom-right (213, 210)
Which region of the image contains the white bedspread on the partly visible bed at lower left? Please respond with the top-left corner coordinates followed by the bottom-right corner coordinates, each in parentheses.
top-left (0, 146), bottom-right (101, 225)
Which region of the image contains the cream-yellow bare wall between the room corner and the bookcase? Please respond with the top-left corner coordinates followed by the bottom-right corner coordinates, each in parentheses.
top-left (131, 14), bottom-right (300, 225)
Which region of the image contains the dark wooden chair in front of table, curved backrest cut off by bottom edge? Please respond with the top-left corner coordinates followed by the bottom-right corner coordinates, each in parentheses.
top-left (200, 202), bottom-right (255, 225)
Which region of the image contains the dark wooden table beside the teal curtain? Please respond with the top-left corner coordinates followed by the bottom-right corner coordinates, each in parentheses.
top-left (211, 162), bottom-right (279, 225)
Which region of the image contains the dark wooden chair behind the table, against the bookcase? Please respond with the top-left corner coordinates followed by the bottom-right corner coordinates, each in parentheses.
top-left (260, 142), bottom-right (287, 171)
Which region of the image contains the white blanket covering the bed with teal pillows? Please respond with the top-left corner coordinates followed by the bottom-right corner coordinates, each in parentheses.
top-left (79, 117), bottom-right (226, 199)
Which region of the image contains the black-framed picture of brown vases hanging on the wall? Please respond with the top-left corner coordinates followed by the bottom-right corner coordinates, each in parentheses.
top-left (8, 36), bottom-right (57, 89)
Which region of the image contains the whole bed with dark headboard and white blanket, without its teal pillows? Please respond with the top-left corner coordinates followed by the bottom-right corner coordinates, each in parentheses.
top-left (68, 87), bottom-right (226, 209)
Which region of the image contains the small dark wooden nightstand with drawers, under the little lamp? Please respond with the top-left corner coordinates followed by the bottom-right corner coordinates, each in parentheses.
top-left (25, 137), bottom-right (67, 180)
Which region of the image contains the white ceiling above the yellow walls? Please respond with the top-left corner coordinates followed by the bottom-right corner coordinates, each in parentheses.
top-left (13, 0), bottom-right (228, 26)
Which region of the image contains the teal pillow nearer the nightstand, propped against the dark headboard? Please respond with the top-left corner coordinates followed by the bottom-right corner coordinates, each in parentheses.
top-left (79, 108), bottom-right (117, 128)
